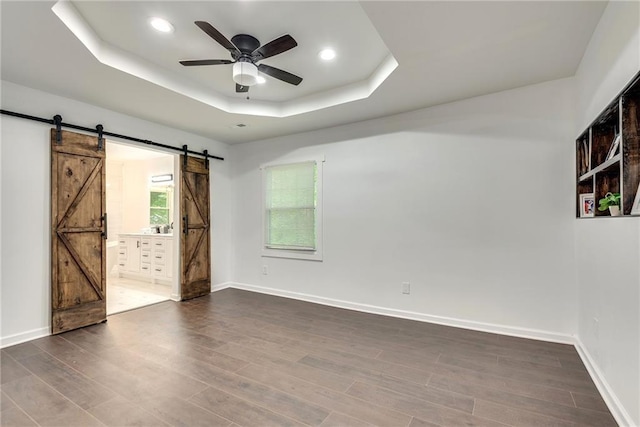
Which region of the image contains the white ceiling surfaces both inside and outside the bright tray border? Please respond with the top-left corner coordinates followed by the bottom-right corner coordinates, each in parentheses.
top-left (0, 0), bottom-right (606, 143)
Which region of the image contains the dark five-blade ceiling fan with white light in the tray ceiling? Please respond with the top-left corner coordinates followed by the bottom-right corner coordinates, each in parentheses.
top-left (180, 21), bottom-right (302, 92)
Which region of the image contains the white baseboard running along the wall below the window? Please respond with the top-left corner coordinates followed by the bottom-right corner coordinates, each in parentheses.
top-left (225, 282), bottom-right (575, 345)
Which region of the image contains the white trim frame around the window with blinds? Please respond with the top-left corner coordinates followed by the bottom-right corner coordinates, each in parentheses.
top-left (260, 157), bottom-right (325, 261)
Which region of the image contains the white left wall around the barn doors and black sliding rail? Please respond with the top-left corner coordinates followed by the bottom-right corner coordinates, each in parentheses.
top-left (0, 81), bottom-right (232, 346)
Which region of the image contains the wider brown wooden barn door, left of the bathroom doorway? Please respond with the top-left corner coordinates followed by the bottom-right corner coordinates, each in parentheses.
top-left (51, 129), bottom-right (106, 334)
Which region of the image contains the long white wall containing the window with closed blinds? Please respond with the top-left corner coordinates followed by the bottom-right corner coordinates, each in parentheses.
top-left (231, 80), bottom-right (576, 340)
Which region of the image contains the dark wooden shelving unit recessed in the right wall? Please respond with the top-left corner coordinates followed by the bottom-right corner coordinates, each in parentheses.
top-left (576, 73), bottom-right (640, 218)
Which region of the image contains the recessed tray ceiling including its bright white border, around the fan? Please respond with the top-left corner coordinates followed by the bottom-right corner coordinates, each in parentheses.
top-left (52, 0), bottom-right (398, 117)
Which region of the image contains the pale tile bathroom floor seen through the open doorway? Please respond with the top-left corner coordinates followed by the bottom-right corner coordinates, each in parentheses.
top-left (107, 276), bottom-right (171, 315)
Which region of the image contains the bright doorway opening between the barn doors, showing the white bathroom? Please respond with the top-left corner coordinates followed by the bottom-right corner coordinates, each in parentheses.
top-left (105, 141), bottom-right (180, 315)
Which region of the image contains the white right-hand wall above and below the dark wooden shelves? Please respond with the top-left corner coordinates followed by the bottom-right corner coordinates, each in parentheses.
top-left (574, 2), bottom-right (640, 426)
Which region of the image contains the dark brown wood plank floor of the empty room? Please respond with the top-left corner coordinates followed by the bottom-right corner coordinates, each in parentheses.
top-left (0, 289), bottom-right (616, 427)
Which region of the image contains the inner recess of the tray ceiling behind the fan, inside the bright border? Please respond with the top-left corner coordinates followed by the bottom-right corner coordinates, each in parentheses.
top-left (73, 1), bottom-right (389, 101)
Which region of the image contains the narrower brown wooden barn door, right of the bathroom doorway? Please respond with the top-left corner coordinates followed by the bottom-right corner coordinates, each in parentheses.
top-left (180, 156), bottom-right (211, 300)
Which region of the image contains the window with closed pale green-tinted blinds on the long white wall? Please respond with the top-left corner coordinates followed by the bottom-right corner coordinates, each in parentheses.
top-left (263, 161), bottom-right (321, 259)
